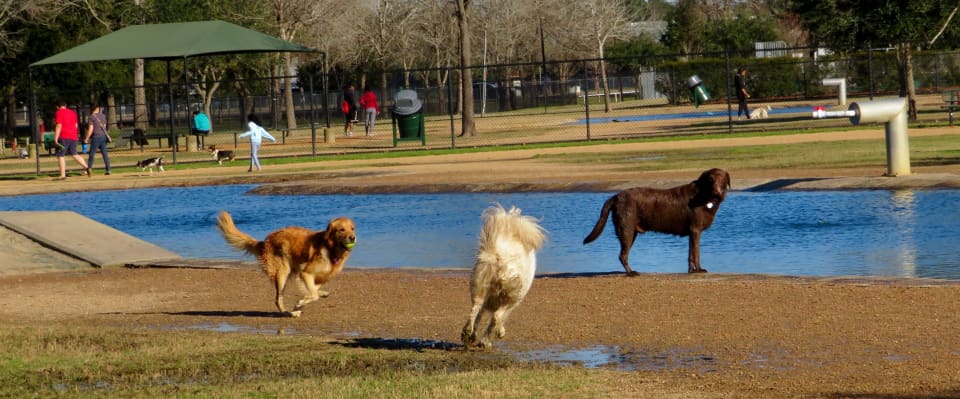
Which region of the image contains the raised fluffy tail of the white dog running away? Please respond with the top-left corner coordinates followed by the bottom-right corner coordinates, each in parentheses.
top-left (480, 204), bottom-right (547, 252)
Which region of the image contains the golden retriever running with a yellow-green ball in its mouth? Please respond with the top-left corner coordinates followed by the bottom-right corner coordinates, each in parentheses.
top-left (217, 211), bottom-right (357, 317)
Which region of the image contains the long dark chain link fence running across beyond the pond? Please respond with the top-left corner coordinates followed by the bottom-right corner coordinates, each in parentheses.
top-left (0, 48), bottom-right (960, 174)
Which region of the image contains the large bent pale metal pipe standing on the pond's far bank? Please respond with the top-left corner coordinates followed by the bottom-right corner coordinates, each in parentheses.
top-left (813, 97), bottom-right (910, 176)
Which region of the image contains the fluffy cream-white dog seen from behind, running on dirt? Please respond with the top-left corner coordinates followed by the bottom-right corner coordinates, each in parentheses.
top-left (460, 204), bottom-right (546, 348)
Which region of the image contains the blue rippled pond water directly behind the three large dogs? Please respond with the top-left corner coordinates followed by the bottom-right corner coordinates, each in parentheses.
top-left (0, 185), bottom-right (960, 279)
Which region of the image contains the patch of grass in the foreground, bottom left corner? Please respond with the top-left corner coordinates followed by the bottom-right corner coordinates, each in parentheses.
top-left (0, 326), bottom-right (614, 398)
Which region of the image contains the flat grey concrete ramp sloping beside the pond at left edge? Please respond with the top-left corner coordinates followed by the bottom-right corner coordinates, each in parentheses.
top-left (0, 211), bottom-right (181, 267)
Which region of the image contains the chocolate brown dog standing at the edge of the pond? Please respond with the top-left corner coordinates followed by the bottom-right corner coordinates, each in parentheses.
top-left (583, 168), bottom-right (730, 276)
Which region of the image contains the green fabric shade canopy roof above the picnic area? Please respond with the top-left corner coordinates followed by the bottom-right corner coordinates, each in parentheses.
top-left (30, 21), bottom-right (316, 66)
